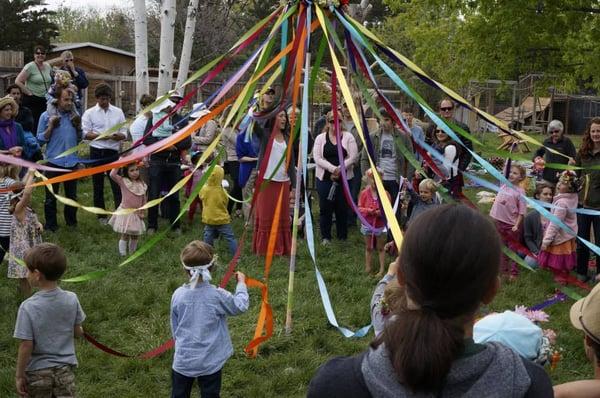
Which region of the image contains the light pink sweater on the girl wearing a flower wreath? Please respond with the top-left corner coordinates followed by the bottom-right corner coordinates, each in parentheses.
top-left (542, 193), bottom-right (577, 246)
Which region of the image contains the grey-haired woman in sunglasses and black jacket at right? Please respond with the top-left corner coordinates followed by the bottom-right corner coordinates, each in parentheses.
top-left (533, 120), bottom-right (576, 185)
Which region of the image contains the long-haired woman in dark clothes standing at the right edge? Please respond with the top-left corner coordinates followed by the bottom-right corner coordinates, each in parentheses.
top-left (575, 117), bottom-right (600, 281)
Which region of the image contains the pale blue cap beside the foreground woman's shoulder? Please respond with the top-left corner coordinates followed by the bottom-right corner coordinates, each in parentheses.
top-left (473, 311), bottom-right (543, 360)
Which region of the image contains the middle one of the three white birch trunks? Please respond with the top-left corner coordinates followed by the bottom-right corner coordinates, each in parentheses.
top-left (156, 0), bottom-right (177, 96)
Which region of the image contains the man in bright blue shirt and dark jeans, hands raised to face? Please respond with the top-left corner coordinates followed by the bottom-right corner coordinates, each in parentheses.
top-left (37, 88), bottom-right (81, 232)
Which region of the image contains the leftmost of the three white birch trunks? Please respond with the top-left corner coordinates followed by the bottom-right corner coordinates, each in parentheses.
top-left (134, 0), bottom-right (150, 112)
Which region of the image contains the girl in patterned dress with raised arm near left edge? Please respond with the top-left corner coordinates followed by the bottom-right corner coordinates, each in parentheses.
top-left (8, 169), bottom-right (44, 297)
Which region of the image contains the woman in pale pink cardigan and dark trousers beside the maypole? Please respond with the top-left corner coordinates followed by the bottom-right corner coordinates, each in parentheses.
top-left (313, 111), bottom-right (360, 244)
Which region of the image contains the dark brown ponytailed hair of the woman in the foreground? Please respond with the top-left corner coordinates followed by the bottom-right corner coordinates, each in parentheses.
top-left (371, 205), bottom-right (500, 393)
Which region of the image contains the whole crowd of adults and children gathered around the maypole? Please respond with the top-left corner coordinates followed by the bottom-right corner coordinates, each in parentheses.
top-left (0, 47), bottom-right (600, 397)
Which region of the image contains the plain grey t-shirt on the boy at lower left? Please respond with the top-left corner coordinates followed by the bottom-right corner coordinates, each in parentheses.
top-left (13, 287), bottom-right (85, 371)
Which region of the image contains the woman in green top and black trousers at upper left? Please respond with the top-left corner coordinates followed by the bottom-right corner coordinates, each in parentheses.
top-left (15, 46), bottom-right (52, 133)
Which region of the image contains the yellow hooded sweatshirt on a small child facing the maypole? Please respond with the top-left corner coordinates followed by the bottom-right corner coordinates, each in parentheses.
top-left (200, 166), bottom-right (231, 225)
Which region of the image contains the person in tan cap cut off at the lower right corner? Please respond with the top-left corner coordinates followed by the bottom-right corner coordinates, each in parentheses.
top-left (554, 285), bottom-right (600, 398)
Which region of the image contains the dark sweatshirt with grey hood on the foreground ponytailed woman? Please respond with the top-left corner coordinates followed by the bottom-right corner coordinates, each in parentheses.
top-left (307, 343), bottom-right (554, 398)
